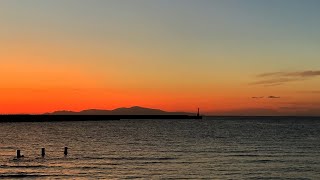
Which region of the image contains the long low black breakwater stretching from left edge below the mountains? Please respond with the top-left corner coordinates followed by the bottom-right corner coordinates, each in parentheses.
top-left (0, 115), bottom-right (202, 123)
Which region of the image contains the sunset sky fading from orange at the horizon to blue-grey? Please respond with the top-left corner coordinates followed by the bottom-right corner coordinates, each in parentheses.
top-left (0, 0), bottom-right (320, 115)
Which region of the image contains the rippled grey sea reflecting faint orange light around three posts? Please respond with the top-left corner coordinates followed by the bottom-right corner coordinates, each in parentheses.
top-left (0, 117), bottom-right (320, 179)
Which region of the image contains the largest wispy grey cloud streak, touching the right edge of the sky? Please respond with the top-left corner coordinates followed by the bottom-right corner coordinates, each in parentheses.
top-left (251, 71), bottom-right (320, 86)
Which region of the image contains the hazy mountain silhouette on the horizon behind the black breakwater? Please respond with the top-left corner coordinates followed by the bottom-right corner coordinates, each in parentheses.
top-left (46, 106), bottom-right (195, 115)
